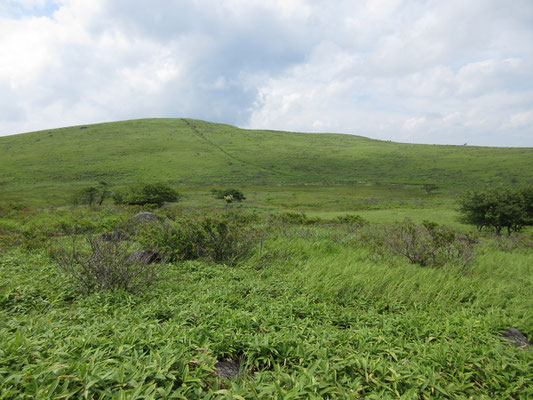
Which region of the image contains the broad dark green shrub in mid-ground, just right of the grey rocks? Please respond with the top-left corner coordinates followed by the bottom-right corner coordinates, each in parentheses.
top-left (139, 214), bottom-right (260, 265)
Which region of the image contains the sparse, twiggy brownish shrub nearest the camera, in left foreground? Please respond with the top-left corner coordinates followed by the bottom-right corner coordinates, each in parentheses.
top-left (53, 236), bottom-right (161, 294)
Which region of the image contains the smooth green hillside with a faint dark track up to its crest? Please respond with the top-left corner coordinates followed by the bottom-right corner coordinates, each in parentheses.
top-left (0, 119), bottom-right (533, 191)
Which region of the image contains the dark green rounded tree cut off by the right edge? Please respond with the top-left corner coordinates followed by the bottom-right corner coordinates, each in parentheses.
top-left (459, 186), bottom-right (533, 235)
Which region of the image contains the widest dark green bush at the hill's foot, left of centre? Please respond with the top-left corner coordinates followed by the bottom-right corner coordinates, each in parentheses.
top-left (113, 182), bottom-right (179, 207)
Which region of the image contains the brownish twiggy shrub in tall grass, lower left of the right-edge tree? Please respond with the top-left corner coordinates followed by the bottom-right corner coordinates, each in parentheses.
top-left (377, 220), bottom-right (473, 267)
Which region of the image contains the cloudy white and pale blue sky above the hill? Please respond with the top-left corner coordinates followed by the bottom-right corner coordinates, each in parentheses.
top-left (0, 0), bottom-right (533, 147)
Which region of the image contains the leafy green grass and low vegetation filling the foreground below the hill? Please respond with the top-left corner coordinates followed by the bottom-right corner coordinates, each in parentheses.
top-left (0, 198), bottom-right (533, 399)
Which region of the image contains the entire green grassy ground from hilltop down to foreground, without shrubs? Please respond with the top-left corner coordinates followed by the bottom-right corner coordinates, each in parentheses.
top-left (0, 120), bottom-right (533, 399)
